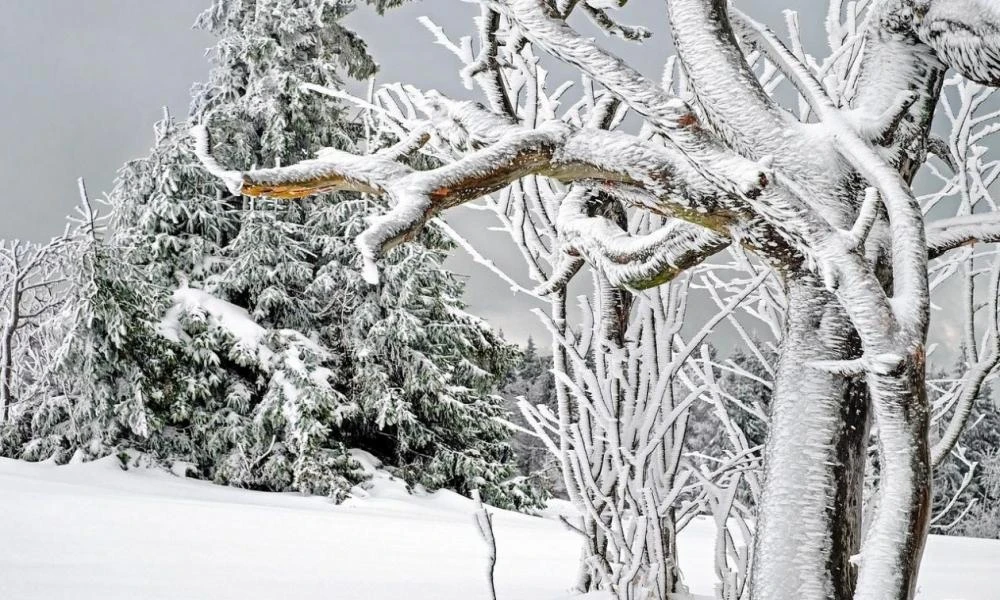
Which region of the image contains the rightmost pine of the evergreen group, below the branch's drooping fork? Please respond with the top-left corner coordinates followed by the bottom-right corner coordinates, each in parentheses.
top-left (331, 223), bottom-right (537, 508)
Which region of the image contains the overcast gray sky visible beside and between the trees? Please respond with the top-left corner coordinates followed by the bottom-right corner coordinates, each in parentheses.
top-left (0, 0), bottom-right (825, 341)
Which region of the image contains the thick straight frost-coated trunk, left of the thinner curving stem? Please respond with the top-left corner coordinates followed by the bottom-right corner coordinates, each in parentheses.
top-left (752, 280), bottom-right (868, 600)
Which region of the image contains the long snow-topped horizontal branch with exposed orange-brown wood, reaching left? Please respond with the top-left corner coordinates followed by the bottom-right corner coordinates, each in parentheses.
top-left (192, 102), bottom-right (752, 282)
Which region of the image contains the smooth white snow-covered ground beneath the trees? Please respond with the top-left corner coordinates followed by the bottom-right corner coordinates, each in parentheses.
top-left (0, 459), bottom-right (1000, 600)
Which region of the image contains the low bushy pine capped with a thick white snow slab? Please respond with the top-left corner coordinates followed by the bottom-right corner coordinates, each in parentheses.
top-left (161, 288), bottom-right (365, 499)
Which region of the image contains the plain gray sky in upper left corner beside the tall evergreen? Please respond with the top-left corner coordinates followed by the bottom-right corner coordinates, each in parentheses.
top-left (0, 0), bottom-right (212, 239)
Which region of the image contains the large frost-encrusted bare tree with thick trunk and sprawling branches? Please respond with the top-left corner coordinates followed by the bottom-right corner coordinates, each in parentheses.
top-left (195, 0), bottom-right (1000, 600)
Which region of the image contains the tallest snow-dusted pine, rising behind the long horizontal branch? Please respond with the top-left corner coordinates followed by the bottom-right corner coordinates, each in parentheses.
top-left (184, 0), bottom-right (534, 506)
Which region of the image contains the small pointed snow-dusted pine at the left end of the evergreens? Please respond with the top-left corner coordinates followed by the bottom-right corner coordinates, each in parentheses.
top-left (16, 190), bottom-right (176, 462)
